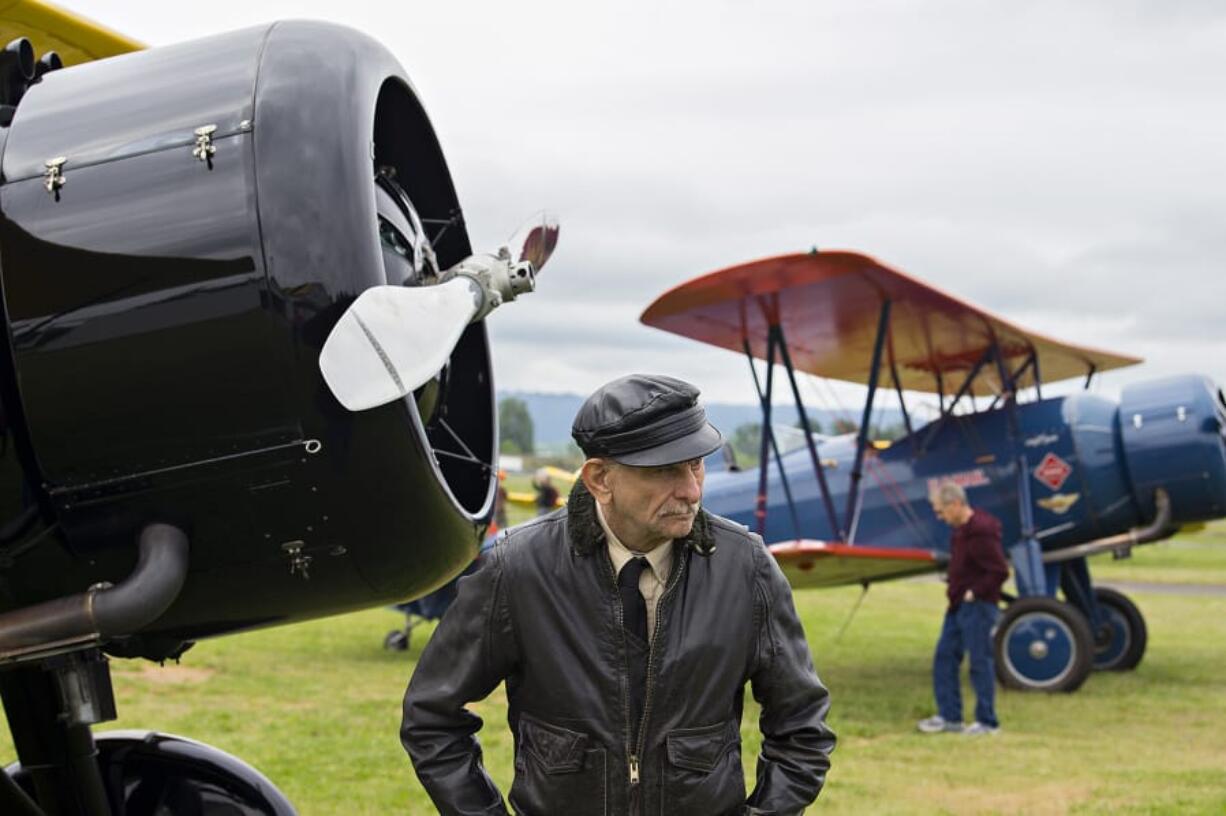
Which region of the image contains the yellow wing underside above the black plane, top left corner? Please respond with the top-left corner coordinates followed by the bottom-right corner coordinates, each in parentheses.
top-left (0, 0), bottom-right (145, 65)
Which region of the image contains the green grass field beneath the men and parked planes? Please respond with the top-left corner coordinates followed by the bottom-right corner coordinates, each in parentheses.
top-left (0, 524), bottom-right (1226, 816)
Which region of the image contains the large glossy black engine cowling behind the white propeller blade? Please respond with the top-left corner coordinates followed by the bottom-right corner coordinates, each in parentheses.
top-left (0, 22), bottom-right (497, 658)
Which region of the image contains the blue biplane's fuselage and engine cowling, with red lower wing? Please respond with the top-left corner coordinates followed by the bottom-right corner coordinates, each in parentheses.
top-left (704, 367), bottom-right (1226, 587)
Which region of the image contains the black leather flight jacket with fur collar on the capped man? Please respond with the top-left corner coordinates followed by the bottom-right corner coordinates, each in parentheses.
top-left (401, 482), bottom-right (835, 816)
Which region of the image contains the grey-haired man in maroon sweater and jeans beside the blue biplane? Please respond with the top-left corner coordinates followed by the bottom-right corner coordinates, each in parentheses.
top-left (920, 482), bottom-right (1009, 734)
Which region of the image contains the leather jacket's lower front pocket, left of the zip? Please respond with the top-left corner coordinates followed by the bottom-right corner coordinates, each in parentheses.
top-left (509, 713), bottom-right (608, 816)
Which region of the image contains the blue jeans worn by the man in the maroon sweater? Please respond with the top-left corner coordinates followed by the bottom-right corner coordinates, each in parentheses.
top-left (932, 600), bottom-right (1000, 727)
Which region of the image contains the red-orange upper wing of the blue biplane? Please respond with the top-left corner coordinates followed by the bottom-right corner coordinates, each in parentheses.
top-left (641, 251), bottom-right (1140, 395)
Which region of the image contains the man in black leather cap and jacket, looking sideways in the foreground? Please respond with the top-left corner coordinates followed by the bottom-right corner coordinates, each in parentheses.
top-left (401, 375), bottom-right (835, 816)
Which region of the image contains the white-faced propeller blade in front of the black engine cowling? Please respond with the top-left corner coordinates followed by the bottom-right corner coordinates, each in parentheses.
top-left (319, 278), bottom-right (478, 410)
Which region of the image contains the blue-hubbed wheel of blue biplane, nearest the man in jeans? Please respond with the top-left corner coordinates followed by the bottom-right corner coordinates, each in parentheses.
top-left (994, 598), bottom-right (1094, 691)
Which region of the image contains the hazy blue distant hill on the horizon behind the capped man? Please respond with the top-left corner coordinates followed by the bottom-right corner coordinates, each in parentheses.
top-left (498, 391), bottom-right (902, 452)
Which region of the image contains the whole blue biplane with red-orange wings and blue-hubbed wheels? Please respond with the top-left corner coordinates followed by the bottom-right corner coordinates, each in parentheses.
top-left (641, 251), bottom-right (1226, 691)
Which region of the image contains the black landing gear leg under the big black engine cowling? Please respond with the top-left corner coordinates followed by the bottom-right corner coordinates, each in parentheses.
top-left (0, 651), bottom-right (115, 816)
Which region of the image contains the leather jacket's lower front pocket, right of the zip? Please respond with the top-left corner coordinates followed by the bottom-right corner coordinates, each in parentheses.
top-left (661, 719), bottom-right (745, 815)
